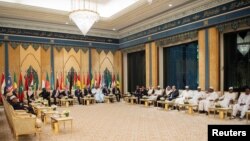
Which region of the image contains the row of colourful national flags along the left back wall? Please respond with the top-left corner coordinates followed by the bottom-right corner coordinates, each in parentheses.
top-left (0, 72), bottom-right (120, 101)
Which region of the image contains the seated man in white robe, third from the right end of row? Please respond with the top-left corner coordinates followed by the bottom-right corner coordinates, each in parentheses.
top-left (198, 87), bottom-right (219, 115)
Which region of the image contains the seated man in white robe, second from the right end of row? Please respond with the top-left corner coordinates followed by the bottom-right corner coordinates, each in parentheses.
top-left (218, 87), bottom-right (237, 108)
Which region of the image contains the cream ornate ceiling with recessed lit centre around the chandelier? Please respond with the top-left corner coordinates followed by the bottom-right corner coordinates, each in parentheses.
top-left (0, 0), bottom-right (232, 38)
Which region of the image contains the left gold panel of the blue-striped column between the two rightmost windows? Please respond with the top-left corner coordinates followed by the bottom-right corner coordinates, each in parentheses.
top-left (198, 30), bottom-right (206, 90)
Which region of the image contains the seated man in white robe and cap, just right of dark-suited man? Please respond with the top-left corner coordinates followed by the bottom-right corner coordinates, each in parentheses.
top-left (175, 86), bottom-right (193, 109)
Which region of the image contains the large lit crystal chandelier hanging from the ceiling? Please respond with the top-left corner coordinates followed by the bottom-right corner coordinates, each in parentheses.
top-left (69, 0), bottom-right (100, 36)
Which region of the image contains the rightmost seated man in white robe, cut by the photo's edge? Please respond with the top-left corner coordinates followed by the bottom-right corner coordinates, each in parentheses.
top-left (230, 88), bottom-right (250, 120)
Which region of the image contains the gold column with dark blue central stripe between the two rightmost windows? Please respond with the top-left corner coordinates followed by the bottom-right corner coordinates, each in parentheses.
top-left (198, 27), bottom-right (220, 91)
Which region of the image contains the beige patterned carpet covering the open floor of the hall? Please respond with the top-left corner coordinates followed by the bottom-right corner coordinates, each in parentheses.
top-left (0, 102), bottom-right (246, 141)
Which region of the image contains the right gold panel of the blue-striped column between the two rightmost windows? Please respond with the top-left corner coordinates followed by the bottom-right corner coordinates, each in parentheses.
top-left (209, 28), bottom-right (220, 90)
